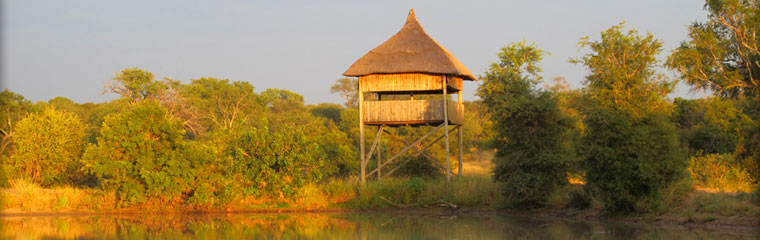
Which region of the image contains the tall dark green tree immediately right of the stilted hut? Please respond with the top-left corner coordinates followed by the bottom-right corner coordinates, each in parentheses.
top-left (477, 42), bottom-right (574, 206)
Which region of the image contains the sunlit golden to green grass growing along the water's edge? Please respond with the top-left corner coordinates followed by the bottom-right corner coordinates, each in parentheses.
top-left (0, 158), bottom-right (760, 225)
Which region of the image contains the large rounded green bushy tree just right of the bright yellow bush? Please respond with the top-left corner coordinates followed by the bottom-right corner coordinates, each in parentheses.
top-left (82, 101), bottom-right (203, 205)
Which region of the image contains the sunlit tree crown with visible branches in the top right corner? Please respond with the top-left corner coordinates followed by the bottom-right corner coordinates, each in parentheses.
top-left (666, 0), bottom-right (760, 101)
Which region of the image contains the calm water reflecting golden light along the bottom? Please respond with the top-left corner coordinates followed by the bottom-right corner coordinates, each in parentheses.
top-left (0, 213), bottom-right (760, 239)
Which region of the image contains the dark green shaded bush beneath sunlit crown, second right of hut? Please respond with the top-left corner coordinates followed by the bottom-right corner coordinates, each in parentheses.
top-left (582, 106), bottom-right (686, 212)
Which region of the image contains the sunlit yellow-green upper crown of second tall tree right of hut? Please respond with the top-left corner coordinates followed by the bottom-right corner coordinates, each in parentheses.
top-left (570, 24), bottom-right (675, 116)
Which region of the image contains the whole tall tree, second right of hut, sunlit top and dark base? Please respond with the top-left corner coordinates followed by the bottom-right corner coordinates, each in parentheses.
top-left (571, 24), bottom-right (686, 212)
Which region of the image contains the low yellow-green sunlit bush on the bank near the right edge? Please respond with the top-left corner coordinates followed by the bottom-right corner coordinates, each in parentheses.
top-left (689, 154), bottom-right (755, 192)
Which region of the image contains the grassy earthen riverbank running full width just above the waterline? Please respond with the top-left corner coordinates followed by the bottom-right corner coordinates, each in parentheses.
top-left (0, 160), bottom-right (760, 231)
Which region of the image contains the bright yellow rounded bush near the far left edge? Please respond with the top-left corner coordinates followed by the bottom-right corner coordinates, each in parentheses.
top-left (9, 107), bottom-right (85, 187)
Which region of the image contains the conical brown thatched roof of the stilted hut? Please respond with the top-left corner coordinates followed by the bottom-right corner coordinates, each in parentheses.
top-left (343, 9), bottom-right (475, 80)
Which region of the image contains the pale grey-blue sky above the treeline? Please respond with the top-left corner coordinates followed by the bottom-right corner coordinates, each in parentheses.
top-left (0, 0), bottom-right (707, 104)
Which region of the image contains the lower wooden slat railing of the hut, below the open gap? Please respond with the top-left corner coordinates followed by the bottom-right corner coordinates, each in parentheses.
top-left (362, 100), bottom-right (464, 125)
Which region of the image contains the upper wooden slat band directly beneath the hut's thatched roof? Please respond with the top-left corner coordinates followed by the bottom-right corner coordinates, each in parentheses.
top-left (359, 73), bottom-right (462, 92)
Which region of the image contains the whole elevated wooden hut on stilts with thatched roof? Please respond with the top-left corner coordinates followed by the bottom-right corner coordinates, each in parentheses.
top-left (343, 9), bottom-right (475, 184)
